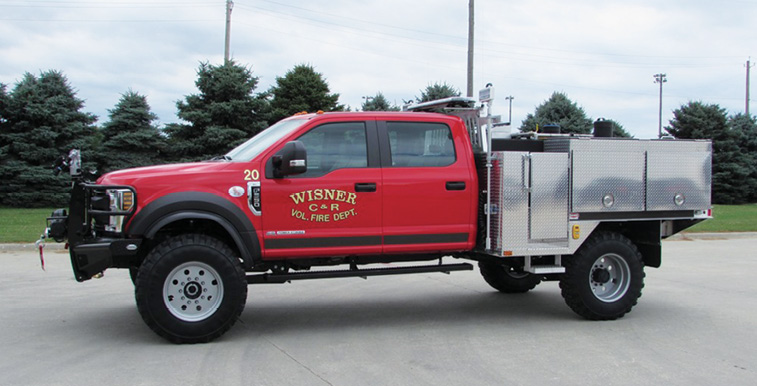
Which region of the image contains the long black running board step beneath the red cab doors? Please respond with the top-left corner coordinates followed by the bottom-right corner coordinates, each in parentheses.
top-left (247, 263), bottom-right (473, 284)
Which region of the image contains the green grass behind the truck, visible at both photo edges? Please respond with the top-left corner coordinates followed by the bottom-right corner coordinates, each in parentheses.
top-left (0, 204), bottom-right (757, 243)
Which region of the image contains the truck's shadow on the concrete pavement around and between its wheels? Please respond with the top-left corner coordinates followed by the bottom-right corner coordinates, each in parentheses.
top-left (54, 284), bottom-right (679, 346)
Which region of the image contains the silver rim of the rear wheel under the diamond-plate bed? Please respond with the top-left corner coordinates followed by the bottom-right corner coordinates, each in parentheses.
top-left (589, 253), bottom-right (631, 303)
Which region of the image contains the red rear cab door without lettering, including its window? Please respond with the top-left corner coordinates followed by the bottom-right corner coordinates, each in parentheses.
top-left (378, 121), bottom-right (478, 253)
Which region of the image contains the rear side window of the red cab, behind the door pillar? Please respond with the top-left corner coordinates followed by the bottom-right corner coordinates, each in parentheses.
top-left (387, 122), bottom-right (455, 167)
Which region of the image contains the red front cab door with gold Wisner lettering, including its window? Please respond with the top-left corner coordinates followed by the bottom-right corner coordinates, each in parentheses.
top-left (261, 121), bottom-right (382, 259)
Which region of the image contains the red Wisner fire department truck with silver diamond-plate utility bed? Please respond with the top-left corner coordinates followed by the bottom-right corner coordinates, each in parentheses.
top-left (45, 98), bottom-right (712, 343)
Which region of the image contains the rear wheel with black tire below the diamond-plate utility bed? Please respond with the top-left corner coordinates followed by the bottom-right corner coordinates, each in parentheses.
top-left (560, 232), bottom-right (644, 320)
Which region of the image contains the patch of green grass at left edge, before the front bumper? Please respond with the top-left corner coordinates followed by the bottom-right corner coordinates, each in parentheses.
top-left (0, 208), bottom-right (53, 243)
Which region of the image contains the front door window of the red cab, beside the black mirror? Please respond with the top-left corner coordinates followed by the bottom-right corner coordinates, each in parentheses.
top-left (297, 122), bottom-right (368, 178)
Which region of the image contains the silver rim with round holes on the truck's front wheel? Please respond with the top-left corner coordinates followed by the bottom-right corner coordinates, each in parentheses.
top-left (163, 261), bottom-right (223, 322)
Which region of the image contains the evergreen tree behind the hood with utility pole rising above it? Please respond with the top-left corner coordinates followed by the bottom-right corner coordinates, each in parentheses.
top-left (165, 60), bottom-right (268, 160)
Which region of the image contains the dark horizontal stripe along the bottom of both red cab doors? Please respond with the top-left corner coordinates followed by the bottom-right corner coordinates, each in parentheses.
top-left (265, 233), bottom-right (469, 249)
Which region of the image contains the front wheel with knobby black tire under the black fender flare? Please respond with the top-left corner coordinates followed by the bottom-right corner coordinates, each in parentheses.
top-left (135, 235), bottom-right (247, 343)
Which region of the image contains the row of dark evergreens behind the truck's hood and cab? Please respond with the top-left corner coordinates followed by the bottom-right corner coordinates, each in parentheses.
top-left (0, 61), bottom-right (460, 207)
